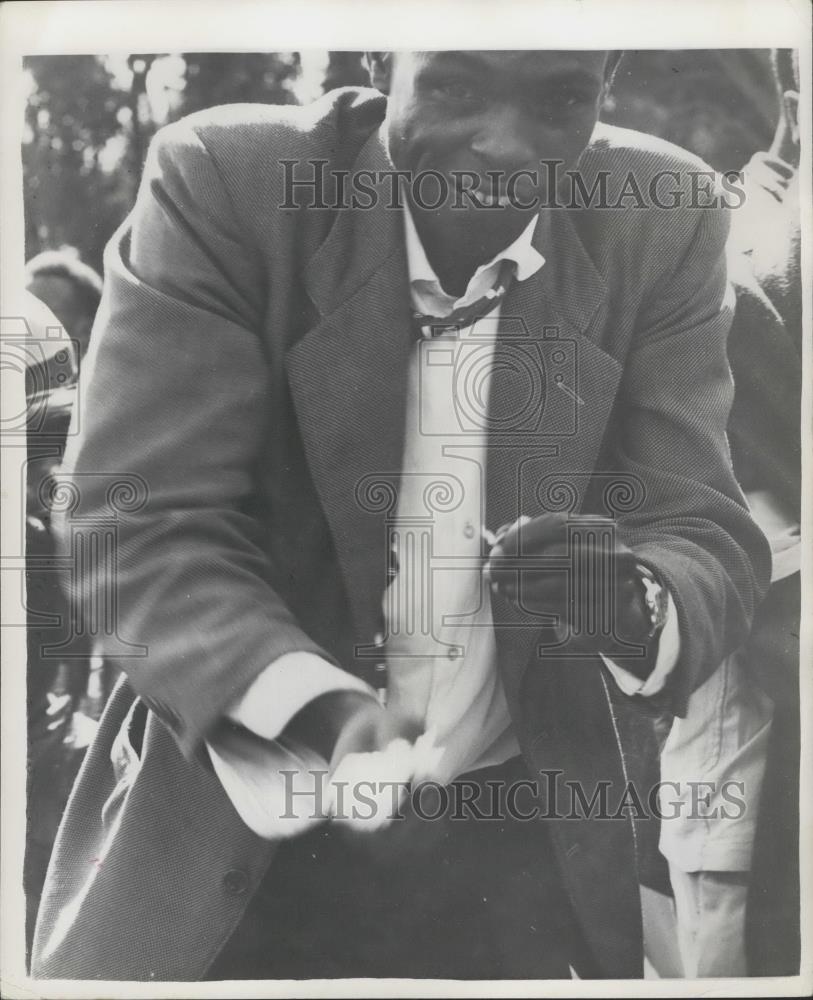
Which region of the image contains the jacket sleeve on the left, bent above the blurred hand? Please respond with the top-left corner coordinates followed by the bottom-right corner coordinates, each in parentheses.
top-left (58, 122), bottom-right (332, 757)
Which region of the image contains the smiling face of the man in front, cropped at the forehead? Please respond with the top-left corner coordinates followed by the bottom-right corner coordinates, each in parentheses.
top-left (374, 51), bottom-right (607, 242)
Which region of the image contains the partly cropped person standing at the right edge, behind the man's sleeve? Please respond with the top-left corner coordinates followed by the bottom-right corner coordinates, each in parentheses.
top-left (660, 50), bottom-right (802, 977)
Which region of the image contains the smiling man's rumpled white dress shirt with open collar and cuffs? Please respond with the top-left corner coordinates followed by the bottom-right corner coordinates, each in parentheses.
top-left (209, 203), bottom-right (679, 837)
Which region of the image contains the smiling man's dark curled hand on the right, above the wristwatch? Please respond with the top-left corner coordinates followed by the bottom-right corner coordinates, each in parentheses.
top-left (486, 513), bottom-right (657, 675)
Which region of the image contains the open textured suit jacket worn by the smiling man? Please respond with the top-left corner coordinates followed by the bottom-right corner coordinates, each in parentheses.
top-left (34, 90), bottom-right (768, 980)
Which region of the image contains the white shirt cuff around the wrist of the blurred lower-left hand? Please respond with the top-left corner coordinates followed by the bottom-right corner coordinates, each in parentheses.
top-left (226, 650), bottom-right (375, 740)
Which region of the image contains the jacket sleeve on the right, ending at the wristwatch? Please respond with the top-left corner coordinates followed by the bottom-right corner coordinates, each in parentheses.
top-left (613, 209), bottom-right (770, 715)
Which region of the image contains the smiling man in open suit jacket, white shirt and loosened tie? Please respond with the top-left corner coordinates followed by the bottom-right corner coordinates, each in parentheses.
top-left (33, 52), bottom-right (768, 980)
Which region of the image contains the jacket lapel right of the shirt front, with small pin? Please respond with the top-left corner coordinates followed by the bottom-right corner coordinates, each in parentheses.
top-left (486, 210), bottom-right (621, 719)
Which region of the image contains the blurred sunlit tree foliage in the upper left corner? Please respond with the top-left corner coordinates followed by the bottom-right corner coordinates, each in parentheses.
top-left (23, 53), bottom-right (300, 271)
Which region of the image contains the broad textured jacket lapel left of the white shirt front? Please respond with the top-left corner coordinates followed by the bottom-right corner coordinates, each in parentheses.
top-left (287, 132), bottom-right (412, 642)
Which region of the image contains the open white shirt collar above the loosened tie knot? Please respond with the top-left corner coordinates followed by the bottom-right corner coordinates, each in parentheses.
top-left (404, 205), bottom-right (545, 315)
